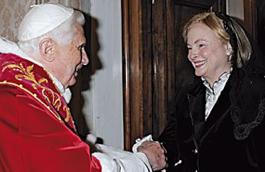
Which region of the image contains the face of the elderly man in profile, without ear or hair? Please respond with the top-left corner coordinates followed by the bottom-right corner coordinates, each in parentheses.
top-left (55, 24), bottom-right (89, 88)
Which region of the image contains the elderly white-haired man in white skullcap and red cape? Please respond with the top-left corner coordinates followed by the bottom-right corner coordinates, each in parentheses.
top-left (0, 4), bottom-right (165, 172)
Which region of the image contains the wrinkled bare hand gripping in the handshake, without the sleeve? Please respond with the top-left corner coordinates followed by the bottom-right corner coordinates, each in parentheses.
top-left (137, 141), bottom-right (167, 171)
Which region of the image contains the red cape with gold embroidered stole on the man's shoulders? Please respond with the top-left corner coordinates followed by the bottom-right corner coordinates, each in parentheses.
top-left (0, 54), bottom-right (101, 172)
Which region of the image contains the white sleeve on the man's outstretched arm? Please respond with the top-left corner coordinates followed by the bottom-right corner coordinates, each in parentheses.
top-left (92, 144), bottom-right (152, 172)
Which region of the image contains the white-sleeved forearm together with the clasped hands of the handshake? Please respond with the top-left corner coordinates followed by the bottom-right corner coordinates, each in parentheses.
top-left (86, 134), bottom-right (167, 172)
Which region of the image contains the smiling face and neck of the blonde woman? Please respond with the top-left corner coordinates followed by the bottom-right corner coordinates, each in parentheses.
top-left (187, 23), bottom-right (231, 86)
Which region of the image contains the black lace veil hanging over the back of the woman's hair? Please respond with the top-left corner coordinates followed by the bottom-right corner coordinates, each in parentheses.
top-left (215, 13), bottom-right (265, 140)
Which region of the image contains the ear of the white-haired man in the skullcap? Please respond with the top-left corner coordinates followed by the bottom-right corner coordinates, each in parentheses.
top-left (39, 38), bottom-right (55, 62)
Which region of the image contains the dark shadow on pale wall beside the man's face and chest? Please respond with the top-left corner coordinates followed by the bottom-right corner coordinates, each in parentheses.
top-left (69, 14), bottom-right (103, 142)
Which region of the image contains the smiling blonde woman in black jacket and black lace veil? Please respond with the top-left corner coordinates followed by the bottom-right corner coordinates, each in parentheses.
top-left (154, 12), bottom-right (265, 172)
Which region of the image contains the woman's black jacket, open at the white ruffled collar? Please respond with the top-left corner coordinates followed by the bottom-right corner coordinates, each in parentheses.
top-left (158, 70), bottom-right (265, 172)
